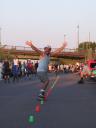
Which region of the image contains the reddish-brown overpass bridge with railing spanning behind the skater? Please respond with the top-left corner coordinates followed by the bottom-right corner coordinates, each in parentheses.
top-left (0, 45), bottom-right (89, 63)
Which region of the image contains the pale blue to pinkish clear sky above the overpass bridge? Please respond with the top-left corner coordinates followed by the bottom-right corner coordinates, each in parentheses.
top-left (0, 0), bottom-right (96, 49)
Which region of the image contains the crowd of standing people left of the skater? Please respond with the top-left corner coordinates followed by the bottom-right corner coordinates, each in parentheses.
top-left (0, 56), bottom-right (38, 82)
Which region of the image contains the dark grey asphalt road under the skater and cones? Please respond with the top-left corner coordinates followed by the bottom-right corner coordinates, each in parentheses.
top-left (0, 74), bottom-right (96, 128)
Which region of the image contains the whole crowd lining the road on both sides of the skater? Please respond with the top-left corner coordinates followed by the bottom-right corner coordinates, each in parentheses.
top-left (0, 57), bottom-right (80, 83)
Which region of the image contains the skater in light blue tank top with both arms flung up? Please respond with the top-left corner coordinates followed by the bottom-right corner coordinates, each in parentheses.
top-left (26, 41), bottom-right (66, 99)
